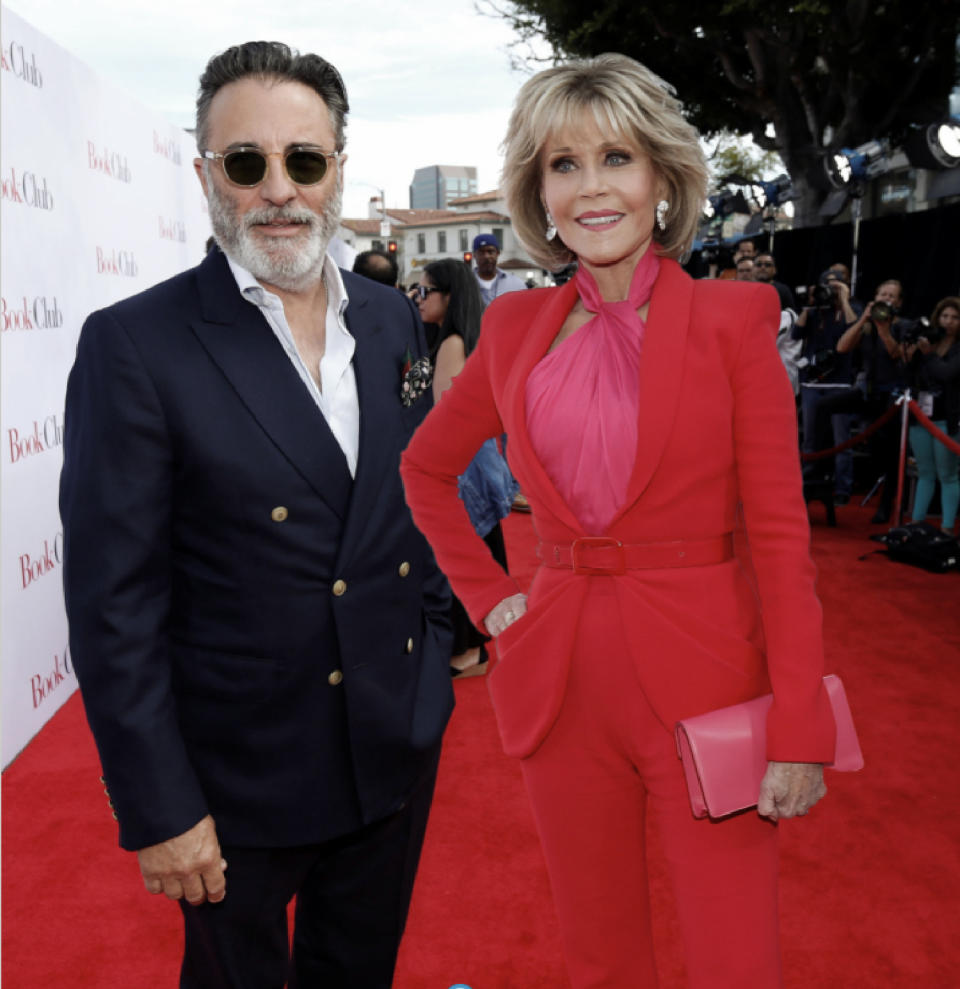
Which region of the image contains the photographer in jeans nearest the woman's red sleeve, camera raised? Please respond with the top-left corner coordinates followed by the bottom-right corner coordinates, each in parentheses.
top-left (793, 264), bottom-right (863, 505)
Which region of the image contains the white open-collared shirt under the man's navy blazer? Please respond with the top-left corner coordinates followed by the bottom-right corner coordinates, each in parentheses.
top-left (227, 255), bottom-right (360, 477)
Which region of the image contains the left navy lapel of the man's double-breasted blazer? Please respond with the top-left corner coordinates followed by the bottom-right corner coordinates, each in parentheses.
top-left (192, 252), bottom-right (352, 519)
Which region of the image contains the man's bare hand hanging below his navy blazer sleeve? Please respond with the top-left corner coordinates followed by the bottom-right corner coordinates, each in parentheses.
top-left (137, 814), bottom-right (227, 906)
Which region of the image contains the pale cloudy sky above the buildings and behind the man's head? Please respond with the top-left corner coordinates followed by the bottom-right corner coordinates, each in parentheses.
top-left (4, 0), bottom-right (552, 216)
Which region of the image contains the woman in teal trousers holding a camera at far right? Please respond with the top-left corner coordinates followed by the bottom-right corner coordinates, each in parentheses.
top-left (905, 295), bottom-right (960, 534)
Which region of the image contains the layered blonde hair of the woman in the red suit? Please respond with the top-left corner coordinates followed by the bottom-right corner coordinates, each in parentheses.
top-left (501, 54), bottom-right (708, 271)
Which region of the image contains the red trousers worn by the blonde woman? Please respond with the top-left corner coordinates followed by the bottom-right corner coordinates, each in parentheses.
top-left (522, 577), bottom-right (782, 989)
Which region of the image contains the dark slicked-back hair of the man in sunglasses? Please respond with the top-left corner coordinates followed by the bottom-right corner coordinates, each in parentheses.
top-left (197, 41), bottom-right (350, 151)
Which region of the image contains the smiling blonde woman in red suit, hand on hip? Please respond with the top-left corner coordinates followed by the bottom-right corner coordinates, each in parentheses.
top-left (402, 55), bottom-right (835, 989)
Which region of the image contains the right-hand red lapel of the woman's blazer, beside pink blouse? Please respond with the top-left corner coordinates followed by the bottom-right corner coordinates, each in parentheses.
top-left (608, 258), bottom-right (693, 528)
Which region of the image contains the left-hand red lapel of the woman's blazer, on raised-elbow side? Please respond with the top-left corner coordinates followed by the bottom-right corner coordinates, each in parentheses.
top-left (503, 279), bottom-right (583, 532)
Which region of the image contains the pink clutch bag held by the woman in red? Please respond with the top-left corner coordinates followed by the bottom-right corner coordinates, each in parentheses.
top-left (676, 675), bottom-right (863, 817)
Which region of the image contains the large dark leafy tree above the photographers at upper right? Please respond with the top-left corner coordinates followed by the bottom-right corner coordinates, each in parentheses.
top-left (481, 0), bottom-right (960, 225)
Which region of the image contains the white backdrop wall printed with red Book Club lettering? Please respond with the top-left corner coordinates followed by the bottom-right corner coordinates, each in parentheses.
top-left (0, 8), bottom-right (210, 766)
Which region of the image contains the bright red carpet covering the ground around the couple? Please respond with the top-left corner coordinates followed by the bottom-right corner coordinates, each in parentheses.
top-left (2, 506), bottom-right (960, 989)
